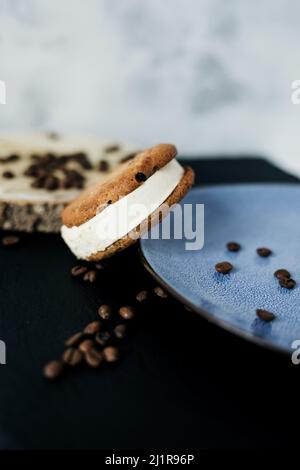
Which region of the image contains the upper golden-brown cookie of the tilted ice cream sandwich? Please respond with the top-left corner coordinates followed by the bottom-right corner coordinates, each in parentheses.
top-left (62, 144), bottom-right (177, 227)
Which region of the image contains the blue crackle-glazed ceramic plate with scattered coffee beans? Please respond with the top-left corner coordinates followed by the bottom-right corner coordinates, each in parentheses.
top-left (141, 184), bottom-right (300, 352)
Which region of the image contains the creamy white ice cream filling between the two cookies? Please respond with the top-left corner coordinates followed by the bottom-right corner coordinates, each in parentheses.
top-left (61, 159), bottom-right (184, 258)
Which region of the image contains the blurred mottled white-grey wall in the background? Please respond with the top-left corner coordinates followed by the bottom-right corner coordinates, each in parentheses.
top-left (0, 0), bottom-right (300, 174)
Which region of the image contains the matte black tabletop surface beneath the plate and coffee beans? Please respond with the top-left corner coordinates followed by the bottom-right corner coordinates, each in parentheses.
top-left (0, 159), bottom-right (300, 449)
